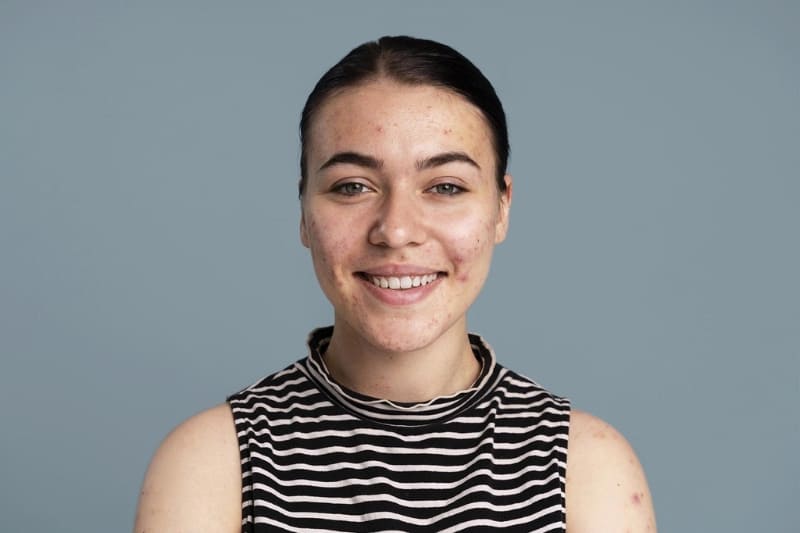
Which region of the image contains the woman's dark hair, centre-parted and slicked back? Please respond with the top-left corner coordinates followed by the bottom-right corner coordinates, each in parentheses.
top-left (298, 36), bottom-right (510, 198)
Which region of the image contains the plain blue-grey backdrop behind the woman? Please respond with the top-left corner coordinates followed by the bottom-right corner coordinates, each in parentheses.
top-left (0, 1), bottom-right (800, 533)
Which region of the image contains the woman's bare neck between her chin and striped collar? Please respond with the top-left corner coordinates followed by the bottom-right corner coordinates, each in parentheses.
top-left (325, 324), bottom-right (480, 403)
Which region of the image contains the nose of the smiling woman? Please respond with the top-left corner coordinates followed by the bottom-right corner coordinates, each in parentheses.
top-left (369, 191), bottom-right (426, 248)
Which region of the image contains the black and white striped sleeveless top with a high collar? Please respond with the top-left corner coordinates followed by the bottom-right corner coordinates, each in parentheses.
top-left (228, 327), bottom-right (570, 533)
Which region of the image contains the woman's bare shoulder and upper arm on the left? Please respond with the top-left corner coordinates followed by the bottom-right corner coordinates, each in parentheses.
top-left (134, 404), bottom-right (242, 533)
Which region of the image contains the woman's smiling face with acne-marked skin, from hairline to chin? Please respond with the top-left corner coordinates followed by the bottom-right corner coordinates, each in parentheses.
top-left (300, 80), bottom-right (511, 352)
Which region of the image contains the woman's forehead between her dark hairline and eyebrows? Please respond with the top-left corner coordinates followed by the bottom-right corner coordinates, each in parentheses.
top-left (308, 80), bottom-right (494, 168)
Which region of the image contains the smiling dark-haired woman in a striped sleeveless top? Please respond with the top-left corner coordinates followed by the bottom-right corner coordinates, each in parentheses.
top-left (136, 37), bottom-right (655, 533)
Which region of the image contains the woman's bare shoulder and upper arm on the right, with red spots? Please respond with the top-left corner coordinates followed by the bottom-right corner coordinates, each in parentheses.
top-left (566, 410), bottom-right (656, 533)
